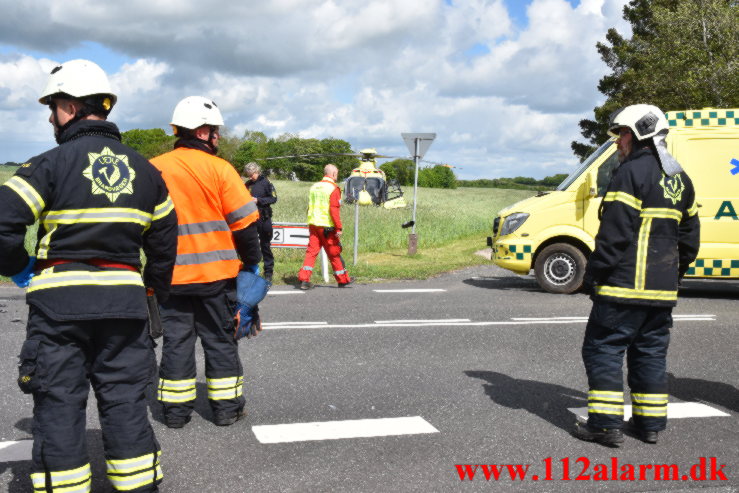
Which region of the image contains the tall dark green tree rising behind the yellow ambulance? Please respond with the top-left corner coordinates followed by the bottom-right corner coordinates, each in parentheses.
top-left (572, 0), bottom-right (739, 160)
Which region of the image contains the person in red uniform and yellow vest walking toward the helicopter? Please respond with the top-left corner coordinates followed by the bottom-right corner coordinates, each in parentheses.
top-left (298, 164), bottom-right (352, 290)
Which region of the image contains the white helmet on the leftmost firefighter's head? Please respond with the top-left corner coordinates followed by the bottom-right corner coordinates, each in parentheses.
top-left (39, 60), bottom-right (118, 112)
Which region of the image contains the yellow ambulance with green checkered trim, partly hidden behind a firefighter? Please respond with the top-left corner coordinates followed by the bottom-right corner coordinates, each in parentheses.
top-left (488, 108), bottom-right (739, 293)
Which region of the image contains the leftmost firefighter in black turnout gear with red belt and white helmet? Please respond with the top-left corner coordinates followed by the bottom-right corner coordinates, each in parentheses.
top-left (0, 60), bottom-right (177, 492)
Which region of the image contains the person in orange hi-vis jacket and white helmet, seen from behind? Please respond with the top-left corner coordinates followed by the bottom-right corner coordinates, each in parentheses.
top-left (151, 96), bottom-right (261, 428)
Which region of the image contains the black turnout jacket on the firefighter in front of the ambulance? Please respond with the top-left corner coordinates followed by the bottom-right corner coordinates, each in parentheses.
top-left (585, 146), bottom-right (700, 306)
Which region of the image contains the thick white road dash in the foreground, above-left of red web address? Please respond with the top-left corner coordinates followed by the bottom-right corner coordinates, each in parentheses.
top-left (252, 416), bottom-right (439, 443)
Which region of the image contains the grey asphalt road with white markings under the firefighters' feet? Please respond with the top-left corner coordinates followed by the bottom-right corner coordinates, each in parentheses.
top-left (0, 266), bottom-right (739, 493)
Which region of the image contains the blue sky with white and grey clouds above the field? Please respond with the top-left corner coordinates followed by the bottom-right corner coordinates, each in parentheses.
top-left (0, 0), bottom-right (628, 179)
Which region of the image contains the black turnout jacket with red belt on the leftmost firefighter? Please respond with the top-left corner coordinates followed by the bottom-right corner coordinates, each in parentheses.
top-left (0, 120), bottom-right (177, 320)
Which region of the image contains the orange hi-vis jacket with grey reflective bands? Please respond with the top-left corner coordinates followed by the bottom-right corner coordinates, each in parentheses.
top-left (151, 147), bottom-right (259, 285)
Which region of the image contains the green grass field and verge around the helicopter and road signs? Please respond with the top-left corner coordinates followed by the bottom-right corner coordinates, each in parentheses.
top-left (0, 166), bottom-right (535, 284)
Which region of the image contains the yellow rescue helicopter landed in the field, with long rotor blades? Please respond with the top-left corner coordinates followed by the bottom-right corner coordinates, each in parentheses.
top-left (258, 148), bottom-right (407, 209)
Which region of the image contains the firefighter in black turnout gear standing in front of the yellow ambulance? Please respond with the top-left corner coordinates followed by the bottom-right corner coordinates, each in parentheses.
top-left (574, 104), bottom-right (700, 447)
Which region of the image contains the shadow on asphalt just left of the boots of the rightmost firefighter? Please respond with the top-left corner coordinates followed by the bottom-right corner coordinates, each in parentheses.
top-left (464, 370), bottom-right (588, 433)
